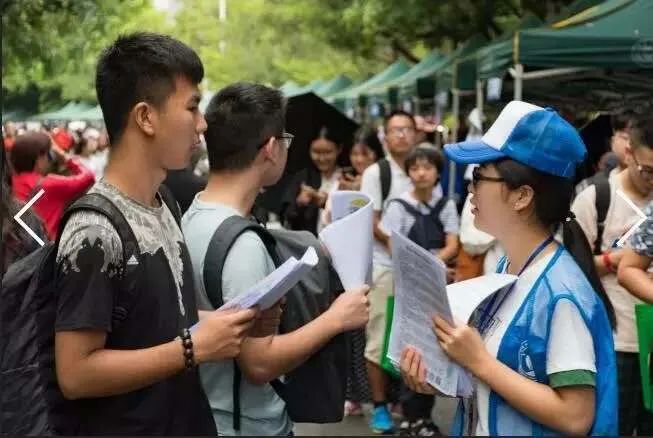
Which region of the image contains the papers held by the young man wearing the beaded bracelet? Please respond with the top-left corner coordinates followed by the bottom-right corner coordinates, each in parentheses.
top-left (190, 247), bottom-right (318, 332)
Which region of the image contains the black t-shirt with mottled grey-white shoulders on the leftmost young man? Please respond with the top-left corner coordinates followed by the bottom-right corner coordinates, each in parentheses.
top-left (56, 181), bottom-right (217, 435)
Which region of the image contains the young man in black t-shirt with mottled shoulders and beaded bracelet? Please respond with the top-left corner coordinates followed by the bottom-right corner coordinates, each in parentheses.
top-left (53, 33), bottom-right (256, 435)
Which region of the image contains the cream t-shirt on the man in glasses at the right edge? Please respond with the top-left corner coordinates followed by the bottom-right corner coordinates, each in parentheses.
top-left (571, 171), bottom-right (653, 353)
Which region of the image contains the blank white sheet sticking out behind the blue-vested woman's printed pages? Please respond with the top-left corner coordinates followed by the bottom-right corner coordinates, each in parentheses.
top-left (447, 274), bottom-right (517, 323)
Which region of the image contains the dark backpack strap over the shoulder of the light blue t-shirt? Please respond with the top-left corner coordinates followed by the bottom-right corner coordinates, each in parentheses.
top-left (202, 215), bottom-right (277, 309)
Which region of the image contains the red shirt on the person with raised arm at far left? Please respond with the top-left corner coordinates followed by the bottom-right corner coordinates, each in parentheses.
top-left (11, 159), bottom-right (95, 240)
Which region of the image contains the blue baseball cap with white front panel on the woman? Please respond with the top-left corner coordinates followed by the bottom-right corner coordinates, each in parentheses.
top-left (444, 100), bottom-right (587, 178)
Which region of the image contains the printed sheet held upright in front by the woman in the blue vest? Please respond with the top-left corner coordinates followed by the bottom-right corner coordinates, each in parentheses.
top-left (388, 232), bottom-right (462, 396)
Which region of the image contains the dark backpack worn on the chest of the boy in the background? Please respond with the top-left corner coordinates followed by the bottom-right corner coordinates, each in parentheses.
top-left (390, 197), bottom-right (449, 251)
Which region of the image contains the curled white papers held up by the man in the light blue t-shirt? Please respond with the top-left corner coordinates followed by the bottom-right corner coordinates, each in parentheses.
top-left (320, 190), bottom-right (374, 289)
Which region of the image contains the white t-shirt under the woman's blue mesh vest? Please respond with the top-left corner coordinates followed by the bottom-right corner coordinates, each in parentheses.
top-left (476, 252), bottom-right (596, 436)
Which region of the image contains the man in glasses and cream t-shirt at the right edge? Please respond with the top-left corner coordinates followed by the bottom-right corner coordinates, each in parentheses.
top-left (572, 118), bottom-right (653, 435)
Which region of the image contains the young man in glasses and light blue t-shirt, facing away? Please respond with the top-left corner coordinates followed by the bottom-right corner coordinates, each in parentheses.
top-left (182, 83), bottom-right (368, 436)
